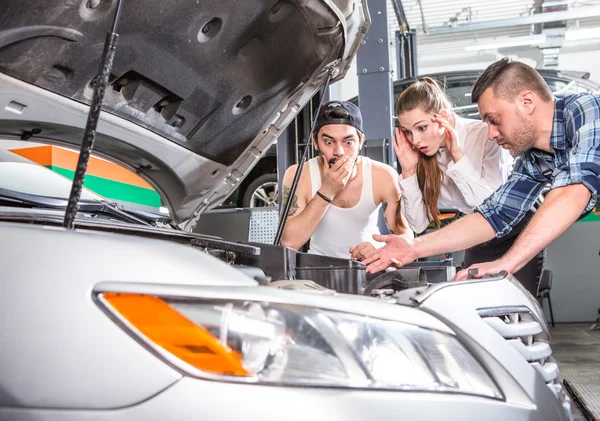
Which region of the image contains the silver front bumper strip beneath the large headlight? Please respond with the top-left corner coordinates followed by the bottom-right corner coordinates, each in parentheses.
top-left (0, 378), bottom-right (559, 421)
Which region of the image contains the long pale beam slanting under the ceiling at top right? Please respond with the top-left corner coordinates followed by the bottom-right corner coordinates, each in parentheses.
top-left (426, 6), bottom-right (600, 35)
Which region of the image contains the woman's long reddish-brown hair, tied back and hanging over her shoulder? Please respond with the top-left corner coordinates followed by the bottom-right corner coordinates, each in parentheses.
top-left (396, 77), bottom-right (452, 228)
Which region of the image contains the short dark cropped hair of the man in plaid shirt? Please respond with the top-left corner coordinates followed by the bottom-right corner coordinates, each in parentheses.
top-left (471, 57), bottom-right (552, 104)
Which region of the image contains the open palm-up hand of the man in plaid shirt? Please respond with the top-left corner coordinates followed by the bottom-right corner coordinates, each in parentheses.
top-left (362, 234), bottom-right (417, 273)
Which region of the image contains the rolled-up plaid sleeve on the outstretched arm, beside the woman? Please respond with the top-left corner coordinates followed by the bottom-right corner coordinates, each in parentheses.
top-left (476, 163), bottom-right (544, 237)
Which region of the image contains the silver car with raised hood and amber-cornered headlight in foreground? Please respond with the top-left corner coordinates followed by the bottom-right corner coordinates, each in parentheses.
top-left (0, 0), bottom-right (571, 421)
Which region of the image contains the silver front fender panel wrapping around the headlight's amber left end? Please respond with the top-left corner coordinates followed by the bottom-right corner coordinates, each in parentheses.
top-left (0, 223), bottom-right (257, 409)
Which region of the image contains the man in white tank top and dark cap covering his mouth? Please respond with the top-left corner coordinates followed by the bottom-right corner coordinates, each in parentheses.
top-left (281, 101), bottom-right (412, 259)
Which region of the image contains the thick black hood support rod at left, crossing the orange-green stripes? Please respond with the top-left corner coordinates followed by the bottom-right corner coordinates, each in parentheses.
top-left (63, 0), bottom-right (123, 229)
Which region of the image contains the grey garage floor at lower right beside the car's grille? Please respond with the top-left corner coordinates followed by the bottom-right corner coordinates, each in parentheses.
top-left (550, 323), bottom-right (600, 420)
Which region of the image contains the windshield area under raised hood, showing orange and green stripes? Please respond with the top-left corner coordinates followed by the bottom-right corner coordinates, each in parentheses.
top-left (0, 139), bottom-right (168, 220)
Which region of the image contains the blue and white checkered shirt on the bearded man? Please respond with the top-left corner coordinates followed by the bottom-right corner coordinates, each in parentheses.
top-left (476, 92), bottom-right (600, 237)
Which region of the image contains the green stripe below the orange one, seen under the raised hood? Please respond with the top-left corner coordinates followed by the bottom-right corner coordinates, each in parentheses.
top-left (47, 166), bottom-right (160, 208)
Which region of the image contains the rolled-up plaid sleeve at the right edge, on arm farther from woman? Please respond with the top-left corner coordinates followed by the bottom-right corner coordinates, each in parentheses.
top-left (552, 120), bottom-right (600, 211)
